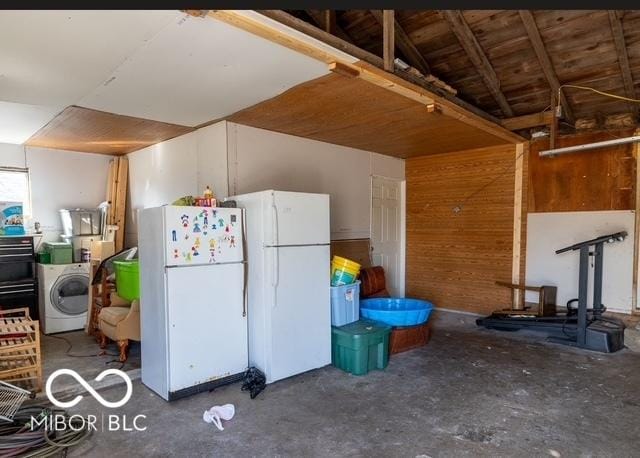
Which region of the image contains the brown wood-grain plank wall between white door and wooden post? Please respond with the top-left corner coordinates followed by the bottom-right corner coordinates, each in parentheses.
top-left (406, 145), bottom-right (526, 313)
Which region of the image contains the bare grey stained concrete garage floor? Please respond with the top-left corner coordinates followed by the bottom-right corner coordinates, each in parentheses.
top-left (61, 313), bottom-right (640, 457)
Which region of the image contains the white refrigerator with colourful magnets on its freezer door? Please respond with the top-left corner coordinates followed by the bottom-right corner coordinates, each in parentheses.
top-left (138, 206), bottom-right (248, 400)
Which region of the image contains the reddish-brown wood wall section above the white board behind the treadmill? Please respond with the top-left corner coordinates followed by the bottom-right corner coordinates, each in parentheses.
top-left (529, 129), bottom-right (636, 212)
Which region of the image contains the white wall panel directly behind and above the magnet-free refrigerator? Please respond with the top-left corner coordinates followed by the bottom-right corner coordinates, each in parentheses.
top-left (228, 123), bottom-right (397, 239)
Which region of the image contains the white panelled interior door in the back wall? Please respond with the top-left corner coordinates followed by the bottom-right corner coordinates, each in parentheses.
top-left (371, 176), bottom-right (404, 296)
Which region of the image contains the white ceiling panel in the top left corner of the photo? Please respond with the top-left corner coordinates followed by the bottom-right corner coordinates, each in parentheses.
top-left (0, 11), bottom-right (181, 109)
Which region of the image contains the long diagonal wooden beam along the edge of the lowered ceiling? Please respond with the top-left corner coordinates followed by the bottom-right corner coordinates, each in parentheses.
top-left (209, 10), bottom-right (525, 143)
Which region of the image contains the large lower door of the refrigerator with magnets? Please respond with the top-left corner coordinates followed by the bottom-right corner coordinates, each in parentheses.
top-left (167, 263), bottom-right (248, 391)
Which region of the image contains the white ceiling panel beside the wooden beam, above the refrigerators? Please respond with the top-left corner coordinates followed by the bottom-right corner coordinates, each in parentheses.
top-left (80, 16), bottom-right (328, 126)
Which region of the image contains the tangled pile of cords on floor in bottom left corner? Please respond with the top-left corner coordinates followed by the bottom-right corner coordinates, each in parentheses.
top-left (0, 405), bottom-right (91, 458)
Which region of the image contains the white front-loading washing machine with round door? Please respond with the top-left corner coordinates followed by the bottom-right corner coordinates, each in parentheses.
top-left (38, 263), bottom-right (90, 334)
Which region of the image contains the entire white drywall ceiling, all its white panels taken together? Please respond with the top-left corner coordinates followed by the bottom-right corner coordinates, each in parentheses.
top-left (0, 11), bottom-right (336, 143)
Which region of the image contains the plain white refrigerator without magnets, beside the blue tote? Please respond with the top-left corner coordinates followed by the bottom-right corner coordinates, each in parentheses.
top-left (228, 190), bottom-right (331, 383)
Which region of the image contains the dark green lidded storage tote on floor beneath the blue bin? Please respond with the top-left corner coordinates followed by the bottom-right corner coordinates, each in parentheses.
top-left (331, 320), bottom-right (391, 375)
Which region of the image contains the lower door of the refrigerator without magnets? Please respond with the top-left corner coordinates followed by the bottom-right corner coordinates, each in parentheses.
top-left (267, 245), bottom-right (331, 383)
